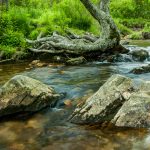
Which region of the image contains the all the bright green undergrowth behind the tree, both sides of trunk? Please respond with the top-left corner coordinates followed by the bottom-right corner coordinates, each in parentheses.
top-left (0, 0), bottom-right (150, 58)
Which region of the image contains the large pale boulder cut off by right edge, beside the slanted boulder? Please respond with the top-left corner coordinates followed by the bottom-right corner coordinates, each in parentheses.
top-left (112, 81), bottom-right (150, 128)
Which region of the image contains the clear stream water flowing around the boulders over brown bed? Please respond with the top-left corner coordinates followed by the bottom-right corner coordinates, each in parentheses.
top-left (0, 41), bottom-right (150, 150)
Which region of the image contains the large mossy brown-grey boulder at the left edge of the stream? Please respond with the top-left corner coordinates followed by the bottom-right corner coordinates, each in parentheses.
top-left (0, 75), bottom-right (60, 117)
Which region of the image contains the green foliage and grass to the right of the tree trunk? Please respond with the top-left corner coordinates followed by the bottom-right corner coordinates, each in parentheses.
top-left (110, 0), bottom-right (150, 35)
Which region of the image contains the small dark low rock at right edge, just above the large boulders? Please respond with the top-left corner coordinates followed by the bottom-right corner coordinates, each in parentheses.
top-left (130, 64), bottom-right (150, 74)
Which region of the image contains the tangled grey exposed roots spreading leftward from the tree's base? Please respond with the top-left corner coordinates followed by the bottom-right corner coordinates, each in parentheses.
top-left (27, 33), bottom-right (126, 55)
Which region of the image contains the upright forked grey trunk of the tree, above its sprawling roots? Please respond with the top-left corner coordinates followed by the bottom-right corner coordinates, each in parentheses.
top-left (80, 0), bottom-right (120, 40)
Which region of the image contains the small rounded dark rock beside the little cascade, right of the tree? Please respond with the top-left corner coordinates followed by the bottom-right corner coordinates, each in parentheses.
top-left (131, 49), bottom-right (149, 61)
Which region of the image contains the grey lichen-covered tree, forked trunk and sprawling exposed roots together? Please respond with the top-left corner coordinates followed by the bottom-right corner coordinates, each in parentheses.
top-left (27, 0), bottom-right (126, 55)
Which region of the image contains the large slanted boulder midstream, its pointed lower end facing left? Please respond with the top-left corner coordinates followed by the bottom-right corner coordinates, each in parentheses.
top-left (70, 75), bottom-right (132, 124)
